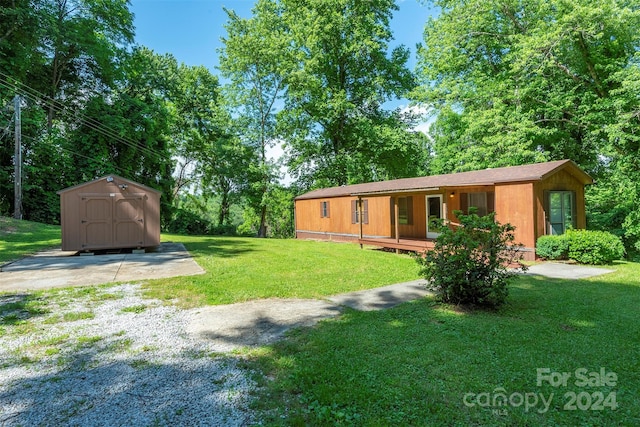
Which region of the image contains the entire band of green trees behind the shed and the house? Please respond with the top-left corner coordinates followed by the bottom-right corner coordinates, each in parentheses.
top-left (0, 0), bottom-right (640, 250)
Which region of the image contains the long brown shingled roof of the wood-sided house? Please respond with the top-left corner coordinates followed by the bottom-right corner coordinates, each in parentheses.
top-left (296, 160), bottom-right (593, 200)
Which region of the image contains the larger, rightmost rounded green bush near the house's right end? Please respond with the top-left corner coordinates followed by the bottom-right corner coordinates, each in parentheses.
top-left (566, 230), bottom-right (625, 264)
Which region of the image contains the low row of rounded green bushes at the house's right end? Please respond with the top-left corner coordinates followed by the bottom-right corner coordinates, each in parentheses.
top-left (536, 230), bottom-right (625, 264)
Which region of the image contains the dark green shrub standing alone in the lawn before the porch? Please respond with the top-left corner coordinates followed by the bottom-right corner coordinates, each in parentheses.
top-left (416, 211), bottom-right (526, 307)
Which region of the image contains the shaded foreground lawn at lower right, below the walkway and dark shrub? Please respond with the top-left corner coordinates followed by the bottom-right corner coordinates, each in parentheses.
top-left (247, 263), bottom-right (640, 426)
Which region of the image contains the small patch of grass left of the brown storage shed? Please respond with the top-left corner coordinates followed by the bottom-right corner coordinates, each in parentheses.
top-left (0, 216), bottom-right (60, 265)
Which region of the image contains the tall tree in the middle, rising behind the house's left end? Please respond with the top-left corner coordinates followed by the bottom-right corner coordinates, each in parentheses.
top-left (279, 0), bottom-right (421, 186)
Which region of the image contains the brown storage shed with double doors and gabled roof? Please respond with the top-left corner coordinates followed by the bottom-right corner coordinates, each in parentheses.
top-left (58, 175), bottom-right (161, 251)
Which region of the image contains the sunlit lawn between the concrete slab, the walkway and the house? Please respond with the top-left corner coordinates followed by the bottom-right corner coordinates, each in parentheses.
top-left (145, 235), bottom-right (418, 307)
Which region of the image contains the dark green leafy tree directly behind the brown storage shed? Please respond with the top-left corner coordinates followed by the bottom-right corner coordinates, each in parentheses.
top-left (66, 48), bottom-right (177, 223)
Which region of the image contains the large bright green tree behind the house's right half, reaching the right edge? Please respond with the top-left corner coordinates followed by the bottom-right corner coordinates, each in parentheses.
top-left (412, 0), bottom-right (640, 252)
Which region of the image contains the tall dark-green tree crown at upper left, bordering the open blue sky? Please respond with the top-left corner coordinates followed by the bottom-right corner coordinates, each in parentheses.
top-left (30, 0), bottom-right (134, 130)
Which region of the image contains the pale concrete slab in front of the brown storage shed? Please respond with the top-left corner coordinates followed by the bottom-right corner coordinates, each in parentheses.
top-left (0, 243), bottom-right (204, 291)
